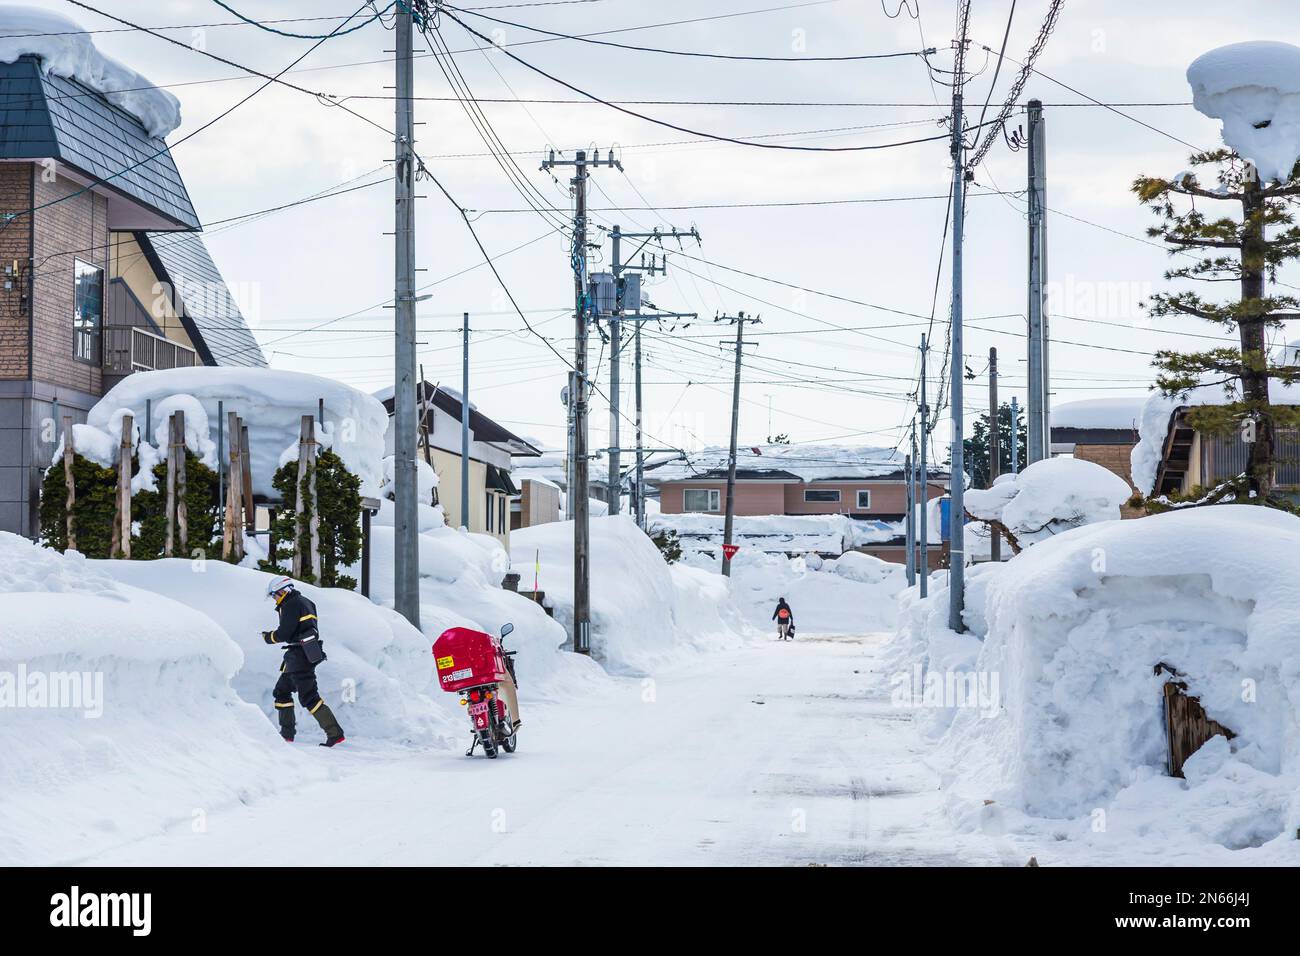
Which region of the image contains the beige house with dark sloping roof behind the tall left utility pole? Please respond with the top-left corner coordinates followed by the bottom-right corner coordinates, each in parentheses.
top-left (374, 382), bottom-right (541, 549)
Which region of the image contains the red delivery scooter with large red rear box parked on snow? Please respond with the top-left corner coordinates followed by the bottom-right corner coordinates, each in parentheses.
top-left (433, 624), bottom-right (519, 758)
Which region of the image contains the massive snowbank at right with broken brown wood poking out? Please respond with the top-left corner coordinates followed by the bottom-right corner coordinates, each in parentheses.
top-left (892, 505), bottom-right (1300, 862)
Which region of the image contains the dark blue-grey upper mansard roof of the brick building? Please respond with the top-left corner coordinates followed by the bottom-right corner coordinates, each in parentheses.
top-left (0, 55), bottom-right (199, 232)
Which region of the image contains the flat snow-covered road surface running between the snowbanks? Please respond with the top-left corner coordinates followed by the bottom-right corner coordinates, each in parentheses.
top-left (82, 635), bottom-right (1024, 865)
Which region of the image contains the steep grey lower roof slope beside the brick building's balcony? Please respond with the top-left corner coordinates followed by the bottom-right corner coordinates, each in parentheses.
top-left (148, 233), bottom-right (267, 367)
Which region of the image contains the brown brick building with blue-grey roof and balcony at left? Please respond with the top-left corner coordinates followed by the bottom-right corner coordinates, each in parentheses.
top-left (0, 55), bottom-right (265, 536)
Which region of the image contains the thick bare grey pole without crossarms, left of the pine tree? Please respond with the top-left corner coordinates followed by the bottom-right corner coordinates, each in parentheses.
top-left (1024, 100), bottom-right (1052, 464)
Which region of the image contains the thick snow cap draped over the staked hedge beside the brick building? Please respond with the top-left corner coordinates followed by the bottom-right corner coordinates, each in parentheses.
top-left (89, 365), bottom-right (389, 498)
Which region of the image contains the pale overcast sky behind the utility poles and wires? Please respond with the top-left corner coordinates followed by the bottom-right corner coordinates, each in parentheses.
top-left (40, 0), bottom-right (1300, 457)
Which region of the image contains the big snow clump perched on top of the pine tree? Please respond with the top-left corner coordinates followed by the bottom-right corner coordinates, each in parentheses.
top-left (1187, 40), bottom-right (1300, 182)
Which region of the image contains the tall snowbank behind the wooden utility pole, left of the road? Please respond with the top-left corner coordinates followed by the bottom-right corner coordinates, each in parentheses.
top-left (510, 515), bottom-right (744, 672)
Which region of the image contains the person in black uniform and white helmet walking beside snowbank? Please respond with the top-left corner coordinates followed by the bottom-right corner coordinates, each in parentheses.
top-left (261, 576), bottom-right (345, 747)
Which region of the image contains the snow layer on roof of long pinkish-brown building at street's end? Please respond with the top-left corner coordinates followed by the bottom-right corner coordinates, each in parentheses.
top-left (646, 445), bottom-right (925, 483)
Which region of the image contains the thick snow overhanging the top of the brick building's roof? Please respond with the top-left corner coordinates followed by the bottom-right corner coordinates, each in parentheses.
top-left (0, 5), bottom-right (181, 139)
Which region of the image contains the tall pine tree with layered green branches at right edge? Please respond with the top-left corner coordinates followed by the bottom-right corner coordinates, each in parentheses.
top-left (1132, 150), bottom-right (1300, 503)
